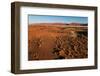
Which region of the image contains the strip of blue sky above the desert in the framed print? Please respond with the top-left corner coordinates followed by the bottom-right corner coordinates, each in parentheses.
top-left (28, 15), bottom-right (88, 24)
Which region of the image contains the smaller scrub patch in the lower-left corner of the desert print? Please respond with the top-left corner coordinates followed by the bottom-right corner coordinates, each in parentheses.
top-left (28, 38), bottom-right (42, 60)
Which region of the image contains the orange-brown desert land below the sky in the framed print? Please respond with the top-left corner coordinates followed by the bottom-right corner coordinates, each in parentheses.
top-left (28, 23), bottom-right (88, 60)
